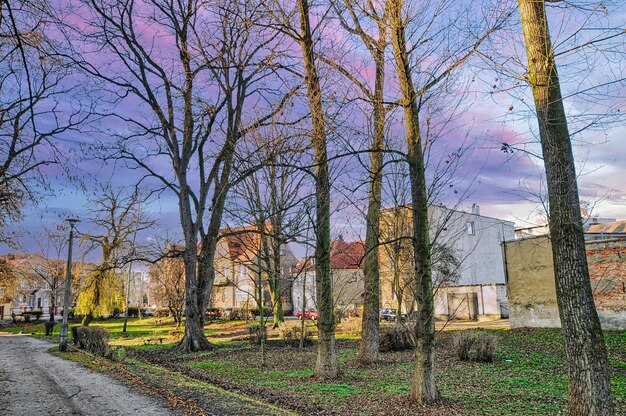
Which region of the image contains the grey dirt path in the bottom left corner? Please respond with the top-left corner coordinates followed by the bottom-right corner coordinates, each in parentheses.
top-left (0, 333), bottom-right (173, 416)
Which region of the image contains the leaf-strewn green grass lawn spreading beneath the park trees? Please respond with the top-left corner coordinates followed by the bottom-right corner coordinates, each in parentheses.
top-left (7, 318), bottom-right (626, 415)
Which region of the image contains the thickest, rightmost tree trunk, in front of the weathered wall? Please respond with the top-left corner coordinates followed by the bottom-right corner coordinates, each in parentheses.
top-left (519, 0), bottom-right (614, 416)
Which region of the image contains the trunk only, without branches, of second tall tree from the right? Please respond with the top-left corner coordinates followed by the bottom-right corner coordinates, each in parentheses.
top-left (390, 0), bottom-right (439, 403)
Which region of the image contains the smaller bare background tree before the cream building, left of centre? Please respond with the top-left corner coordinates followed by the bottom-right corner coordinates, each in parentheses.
top-left (230, 125), bottom-right (308, 328)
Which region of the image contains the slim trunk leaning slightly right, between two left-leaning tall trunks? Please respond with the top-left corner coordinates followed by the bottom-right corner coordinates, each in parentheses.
top-left (359, 22), bottom-right (387, 364)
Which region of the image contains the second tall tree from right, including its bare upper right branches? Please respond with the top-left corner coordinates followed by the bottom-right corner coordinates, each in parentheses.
top-left (389, 0), bottom-right (508, 403)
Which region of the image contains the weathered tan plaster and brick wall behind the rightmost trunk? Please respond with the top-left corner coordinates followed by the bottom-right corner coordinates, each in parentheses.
top-left (504, 236), bottom-right (626, 330)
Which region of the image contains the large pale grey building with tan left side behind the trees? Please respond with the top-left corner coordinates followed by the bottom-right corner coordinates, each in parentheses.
top-left (379, 205), bottom-right (515, 319)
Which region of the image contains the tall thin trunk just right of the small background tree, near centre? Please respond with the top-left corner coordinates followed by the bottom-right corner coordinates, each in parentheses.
top-left (298, 0), bottom-right (338, 379)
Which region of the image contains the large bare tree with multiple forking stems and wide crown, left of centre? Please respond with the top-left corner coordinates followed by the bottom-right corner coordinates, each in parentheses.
top-left (59, 0), bottom-right (292, 352)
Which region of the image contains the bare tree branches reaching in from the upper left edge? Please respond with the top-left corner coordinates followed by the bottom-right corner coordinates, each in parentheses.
top-left (0, 0), bottom-right (89, 242)
